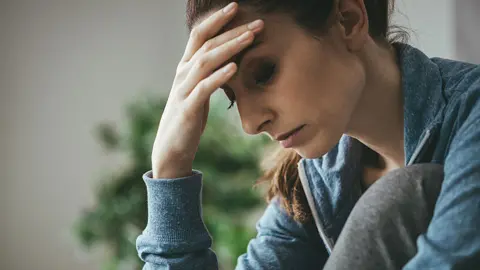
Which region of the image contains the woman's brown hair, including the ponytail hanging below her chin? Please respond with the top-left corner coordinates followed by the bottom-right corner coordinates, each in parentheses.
top-left (187, 0), bottom-right (407, 223)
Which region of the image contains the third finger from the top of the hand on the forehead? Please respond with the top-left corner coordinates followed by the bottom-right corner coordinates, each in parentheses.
top-left (182, 31), bottom-right (253, 95)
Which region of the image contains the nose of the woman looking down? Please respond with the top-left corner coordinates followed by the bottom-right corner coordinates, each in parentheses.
top-left (238, 100), bottom-right (274, 135)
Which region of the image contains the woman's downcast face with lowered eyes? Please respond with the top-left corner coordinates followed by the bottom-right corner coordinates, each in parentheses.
top-left (209, 9), bottom-right (365, 158)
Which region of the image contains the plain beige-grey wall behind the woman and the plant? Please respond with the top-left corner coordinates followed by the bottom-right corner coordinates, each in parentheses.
top-left (0, 0), bottom-right (464, 270)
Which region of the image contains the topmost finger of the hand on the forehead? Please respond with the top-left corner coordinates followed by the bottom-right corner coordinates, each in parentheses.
top-left (182, 2), bottom-right (238, 62)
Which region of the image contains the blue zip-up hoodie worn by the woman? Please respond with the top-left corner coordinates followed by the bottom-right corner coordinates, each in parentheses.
top-left (137, 44), bottom-right (480, 270)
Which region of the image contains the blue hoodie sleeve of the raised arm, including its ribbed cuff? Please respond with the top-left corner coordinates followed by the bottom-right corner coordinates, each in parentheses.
top-left (137, 171), bottom-right (327, 270)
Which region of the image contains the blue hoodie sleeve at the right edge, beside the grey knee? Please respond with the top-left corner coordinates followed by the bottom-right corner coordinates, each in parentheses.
top-left (404, 86), bottom-right (480, 270)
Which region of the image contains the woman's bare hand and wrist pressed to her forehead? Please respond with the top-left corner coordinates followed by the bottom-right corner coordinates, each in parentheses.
top-left (152, 3), bottom-right (263, 178)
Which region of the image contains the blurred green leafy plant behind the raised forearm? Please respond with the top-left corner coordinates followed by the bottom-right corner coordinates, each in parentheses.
top-left (74, 92), bottom-right (268, 270)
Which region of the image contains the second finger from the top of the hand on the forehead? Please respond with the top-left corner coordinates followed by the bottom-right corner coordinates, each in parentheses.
top-left (190, 20), bottom-right (264, 62)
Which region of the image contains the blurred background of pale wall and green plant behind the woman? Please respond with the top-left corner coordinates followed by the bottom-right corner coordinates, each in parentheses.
top-left (0, 0), bottom-right (480, 270)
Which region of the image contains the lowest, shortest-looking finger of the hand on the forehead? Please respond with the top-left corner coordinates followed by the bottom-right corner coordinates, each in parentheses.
top-left (186, 62), bottom-right (237, 109)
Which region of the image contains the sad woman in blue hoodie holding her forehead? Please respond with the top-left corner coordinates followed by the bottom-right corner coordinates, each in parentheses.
top-left (137, 0), bottom-right (480, 269)
